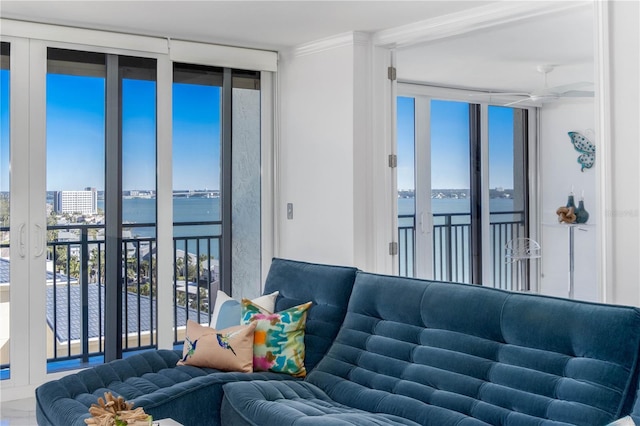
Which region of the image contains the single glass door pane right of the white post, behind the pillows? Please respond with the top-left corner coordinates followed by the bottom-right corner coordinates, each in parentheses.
top-left (173, 63), bottom-right (223, 342)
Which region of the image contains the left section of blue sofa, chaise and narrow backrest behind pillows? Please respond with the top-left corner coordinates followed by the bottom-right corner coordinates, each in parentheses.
top-left (36, 259), bottom-right (356, 426)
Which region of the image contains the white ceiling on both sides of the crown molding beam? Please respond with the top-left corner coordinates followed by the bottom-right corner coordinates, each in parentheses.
top-left (0, 0), bottom-right (593, 91)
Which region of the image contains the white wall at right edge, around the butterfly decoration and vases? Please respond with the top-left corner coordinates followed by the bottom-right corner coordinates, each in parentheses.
top-left (541, 1), bottom-right (640, 306)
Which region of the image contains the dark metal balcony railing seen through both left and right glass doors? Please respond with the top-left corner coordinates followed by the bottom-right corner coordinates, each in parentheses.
top-left (0, 211), bottom-right (524, 374)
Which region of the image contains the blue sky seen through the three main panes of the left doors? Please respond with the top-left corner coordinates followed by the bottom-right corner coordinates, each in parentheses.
top-left (35, 74), bottom-right (220, 191)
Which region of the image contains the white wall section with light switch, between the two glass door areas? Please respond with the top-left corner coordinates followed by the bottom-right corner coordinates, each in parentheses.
top-left (276, 35), bottom-right (355, 265)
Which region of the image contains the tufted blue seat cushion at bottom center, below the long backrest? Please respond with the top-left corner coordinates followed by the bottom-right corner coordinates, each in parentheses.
top-left (221, 381), bottom-right (428, 426)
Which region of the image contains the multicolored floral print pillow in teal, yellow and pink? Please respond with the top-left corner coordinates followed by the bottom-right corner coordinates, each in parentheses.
top-left (242, 299), bottom-right (313, 377)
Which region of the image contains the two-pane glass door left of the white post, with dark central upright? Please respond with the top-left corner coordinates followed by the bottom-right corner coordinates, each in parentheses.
top-left (46, 48), bottom-right (157, 369)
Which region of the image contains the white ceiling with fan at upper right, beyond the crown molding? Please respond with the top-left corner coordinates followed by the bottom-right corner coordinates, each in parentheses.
top-left (397, 5), bottom-right (595, 92)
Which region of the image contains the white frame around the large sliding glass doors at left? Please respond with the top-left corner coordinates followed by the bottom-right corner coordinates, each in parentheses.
top-left (0, 24), bottom-right (277, 400)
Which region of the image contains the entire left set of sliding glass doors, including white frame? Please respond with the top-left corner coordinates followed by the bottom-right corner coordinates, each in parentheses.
top-left (0, 24), bottom-right (276, 391)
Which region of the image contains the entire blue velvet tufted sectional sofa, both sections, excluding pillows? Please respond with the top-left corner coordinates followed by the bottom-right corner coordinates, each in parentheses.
top-left (36, 259), bottom-right (640, 426)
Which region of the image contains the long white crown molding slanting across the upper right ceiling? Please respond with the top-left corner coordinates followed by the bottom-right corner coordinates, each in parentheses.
top-left (373, 0), bottom-right (593, 49)
